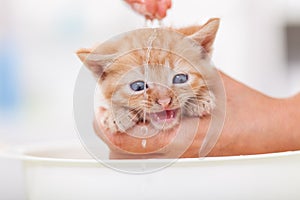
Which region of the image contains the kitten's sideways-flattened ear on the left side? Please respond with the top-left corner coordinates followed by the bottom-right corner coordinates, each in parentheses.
top-left (76, 49), bottom-right (115, 77)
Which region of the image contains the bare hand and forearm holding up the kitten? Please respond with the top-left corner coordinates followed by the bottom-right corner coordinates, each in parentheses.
top-left (94, 72), bottom-right (300, 159)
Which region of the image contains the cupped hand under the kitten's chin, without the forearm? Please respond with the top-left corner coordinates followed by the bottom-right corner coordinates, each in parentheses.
top-left (94, 107), bottom-right (210, 159)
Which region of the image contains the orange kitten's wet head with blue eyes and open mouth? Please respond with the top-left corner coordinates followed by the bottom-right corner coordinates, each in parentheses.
top-left (77, 19), bottom-right (219, 129)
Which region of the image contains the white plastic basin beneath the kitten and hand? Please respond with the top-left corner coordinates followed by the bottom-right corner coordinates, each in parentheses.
top-left (4, 143), bottom-right (300, 200)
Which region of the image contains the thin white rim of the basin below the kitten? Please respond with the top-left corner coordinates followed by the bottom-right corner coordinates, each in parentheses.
top-left (3, 142), bottom-right (300, 164)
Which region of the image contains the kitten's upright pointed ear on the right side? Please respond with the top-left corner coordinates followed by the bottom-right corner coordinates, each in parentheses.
top-left (188, 18), bottom-right (220, 54)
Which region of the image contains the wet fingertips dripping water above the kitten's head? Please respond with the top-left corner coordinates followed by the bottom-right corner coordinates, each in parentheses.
top-left (125, 0), bottom-right (172, 20)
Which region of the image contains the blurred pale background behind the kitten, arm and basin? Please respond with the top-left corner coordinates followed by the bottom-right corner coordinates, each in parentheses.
top-left (0, 0), bottom-right (300, 200)
